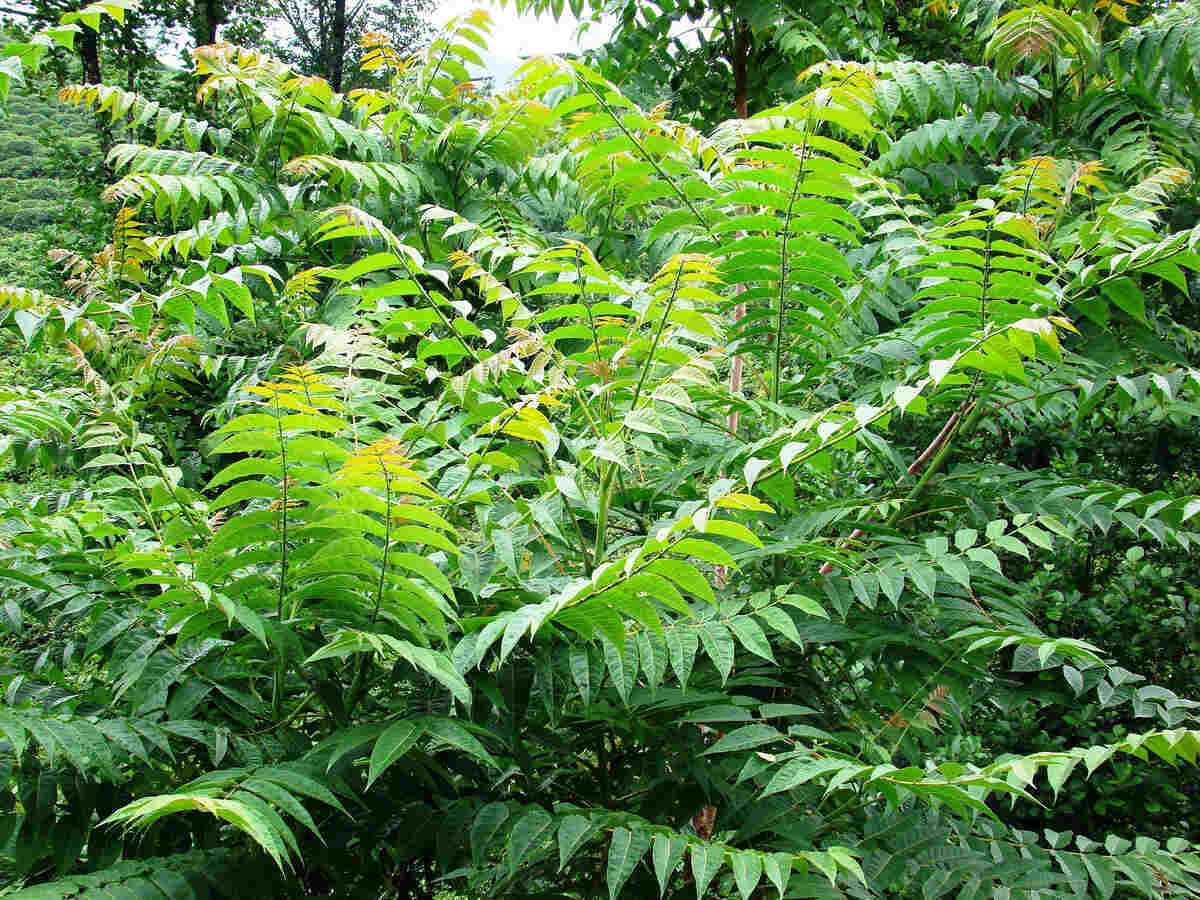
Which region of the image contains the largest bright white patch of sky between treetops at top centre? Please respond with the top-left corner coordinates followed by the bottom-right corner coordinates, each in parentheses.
top-left (434, 0), bottom-right (612, 86)
